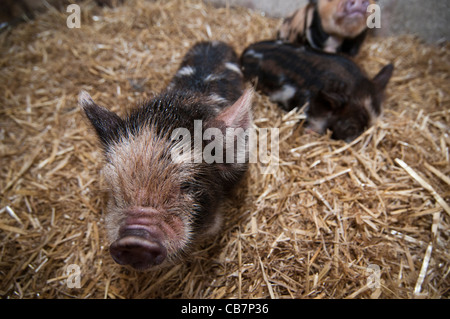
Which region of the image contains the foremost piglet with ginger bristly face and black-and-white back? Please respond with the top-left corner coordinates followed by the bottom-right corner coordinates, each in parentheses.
top-left (79, 41), bottom-right (252, 270)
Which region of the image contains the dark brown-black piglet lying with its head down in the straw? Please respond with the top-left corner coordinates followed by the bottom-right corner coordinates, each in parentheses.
top-left (241, 41), bottom-right (393, 142)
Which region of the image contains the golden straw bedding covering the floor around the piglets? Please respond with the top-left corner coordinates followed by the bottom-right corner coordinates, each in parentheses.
top-left (0, 0), bottom-right (450, 298)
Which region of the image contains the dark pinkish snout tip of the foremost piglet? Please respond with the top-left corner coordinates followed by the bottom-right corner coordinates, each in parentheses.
top-left (109, 230), bottom-right (167, 270)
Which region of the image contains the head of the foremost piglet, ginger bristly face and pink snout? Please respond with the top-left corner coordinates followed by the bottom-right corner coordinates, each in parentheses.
top-left (79, 92), bottom-right (251, 270)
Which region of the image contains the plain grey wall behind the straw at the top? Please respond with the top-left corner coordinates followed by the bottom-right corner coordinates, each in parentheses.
top-left (206, 0), bottom-right (450, 43)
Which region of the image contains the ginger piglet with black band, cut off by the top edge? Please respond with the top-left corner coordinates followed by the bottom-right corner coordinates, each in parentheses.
top-left (277, 0), bottom-right (375, 56)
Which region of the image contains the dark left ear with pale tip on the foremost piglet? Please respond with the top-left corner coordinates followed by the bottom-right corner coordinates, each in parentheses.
top-left (78, 91), bottom-right (122, 146)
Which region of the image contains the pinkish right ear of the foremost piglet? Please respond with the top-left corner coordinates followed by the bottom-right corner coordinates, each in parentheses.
top-left (215, 88), bottom-right (254, 130)
